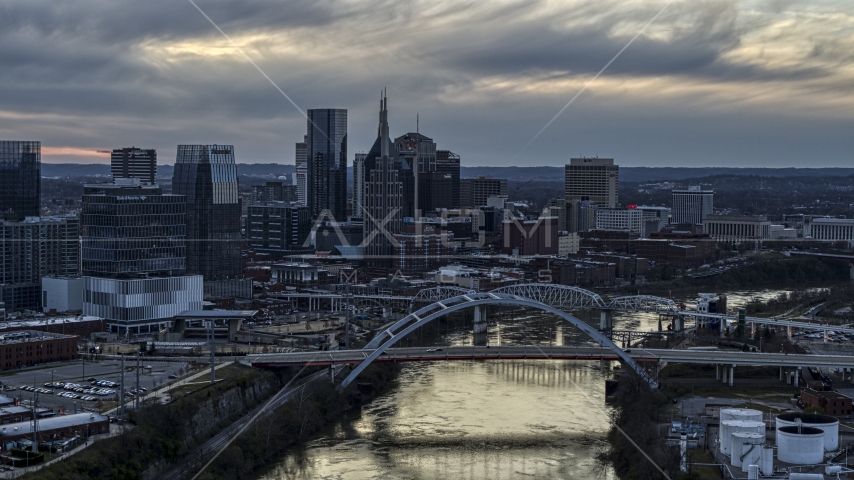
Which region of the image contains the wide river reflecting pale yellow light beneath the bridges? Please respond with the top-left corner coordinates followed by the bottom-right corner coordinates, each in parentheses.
top-left (260, 287), bottom-right (844, 480)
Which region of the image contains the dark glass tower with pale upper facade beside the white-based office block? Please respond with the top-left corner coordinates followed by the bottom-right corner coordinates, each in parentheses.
top-left (172, 145), bottom-right (242, 281)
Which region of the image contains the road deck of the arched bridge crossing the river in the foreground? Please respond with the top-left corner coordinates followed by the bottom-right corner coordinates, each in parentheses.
top-left (247, 346), bottom-right (854, 367)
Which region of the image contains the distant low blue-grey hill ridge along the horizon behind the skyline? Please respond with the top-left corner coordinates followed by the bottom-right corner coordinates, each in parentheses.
top-left (42, 163), bottom-right (854, 182)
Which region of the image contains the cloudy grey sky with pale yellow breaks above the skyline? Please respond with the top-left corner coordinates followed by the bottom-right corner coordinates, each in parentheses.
top-left (0, 0), bottom-right (854, 167)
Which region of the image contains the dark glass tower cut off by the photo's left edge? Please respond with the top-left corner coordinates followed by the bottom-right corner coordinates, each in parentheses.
top-left (0, 140), bottom-right (41, 221)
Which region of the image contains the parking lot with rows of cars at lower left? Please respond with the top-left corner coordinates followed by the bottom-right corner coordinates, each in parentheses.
top-left (0, 359), bottom-right (196, 412)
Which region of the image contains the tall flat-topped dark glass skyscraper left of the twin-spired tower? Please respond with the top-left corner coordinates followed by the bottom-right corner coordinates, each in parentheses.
top-left (306, 108), bottom-right (347, 222)
